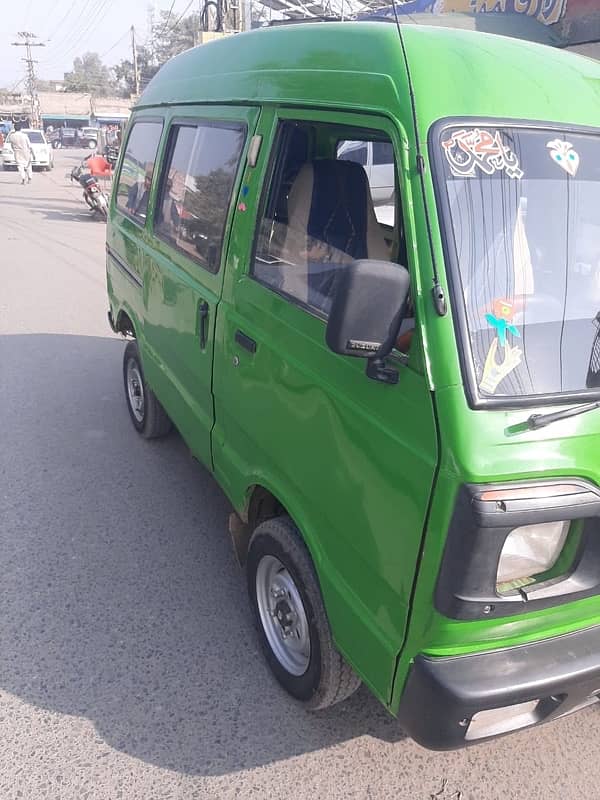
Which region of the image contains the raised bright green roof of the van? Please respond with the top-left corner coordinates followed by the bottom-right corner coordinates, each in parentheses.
top-left (137, 21), bottom-right (600, 136)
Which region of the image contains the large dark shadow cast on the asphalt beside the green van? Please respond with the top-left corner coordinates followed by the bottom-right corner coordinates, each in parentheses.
top-left (0, 335), bottom-right (410, 775)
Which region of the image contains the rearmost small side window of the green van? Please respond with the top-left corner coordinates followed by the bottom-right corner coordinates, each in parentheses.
top-left (116, 120), bottom-right (163, 224)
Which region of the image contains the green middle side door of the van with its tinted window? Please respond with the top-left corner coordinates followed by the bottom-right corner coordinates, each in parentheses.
top-left (144, 108), bottom-right (257, 467)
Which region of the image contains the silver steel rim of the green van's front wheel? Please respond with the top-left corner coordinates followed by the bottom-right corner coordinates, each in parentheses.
top-left (256, 555), bottom-right (310, 676)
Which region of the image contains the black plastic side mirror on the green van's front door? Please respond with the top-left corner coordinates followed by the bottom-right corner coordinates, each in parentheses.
top-left (325, 260), bottom-right (410, 383)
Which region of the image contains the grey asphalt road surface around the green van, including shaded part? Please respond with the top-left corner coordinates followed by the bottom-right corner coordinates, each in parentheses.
top-left (0, 151), bottom-right (600, 800)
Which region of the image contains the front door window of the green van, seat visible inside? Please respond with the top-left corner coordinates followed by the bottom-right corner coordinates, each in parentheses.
top-left (252, 123), bottom-right (406, 316)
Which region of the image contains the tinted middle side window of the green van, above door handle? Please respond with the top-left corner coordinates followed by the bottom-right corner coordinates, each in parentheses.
top-left (154, 122), bottom-right (245, 272)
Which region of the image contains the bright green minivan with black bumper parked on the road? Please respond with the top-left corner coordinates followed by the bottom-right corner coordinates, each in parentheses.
top-left (107, 21), bottom-right (600, 749)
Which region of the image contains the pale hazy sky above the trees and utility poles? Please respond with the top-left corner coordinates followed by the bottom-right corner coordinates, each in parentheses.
top-left (0, 0), bottom-right (183, 88)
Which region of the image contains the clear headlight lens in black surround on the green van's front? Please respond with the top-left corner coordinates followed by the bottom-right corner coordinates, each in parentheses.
top-left (496, 522), bottom-right (570, 585)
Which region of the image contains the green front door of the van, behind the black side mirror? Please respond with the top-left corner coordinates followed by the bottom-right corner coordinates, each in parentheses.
top-left (213, 112), bottom-right (437, 702)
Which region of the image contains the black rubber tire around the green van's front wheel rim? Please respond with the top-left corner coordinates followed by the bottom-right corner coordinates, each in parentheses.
top-left (246, 516), bottom-right (361, 711)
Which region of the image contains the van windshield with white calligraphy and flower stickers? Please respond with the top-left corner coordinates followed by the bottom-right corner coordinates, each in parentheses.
top-left (435, 124), bottom-right (600, 402)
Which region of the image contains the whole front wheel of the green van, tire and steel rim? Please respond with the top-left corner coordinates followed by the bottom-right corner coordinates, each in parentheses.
top-left (246, 516), bottom-right (360, 710)
